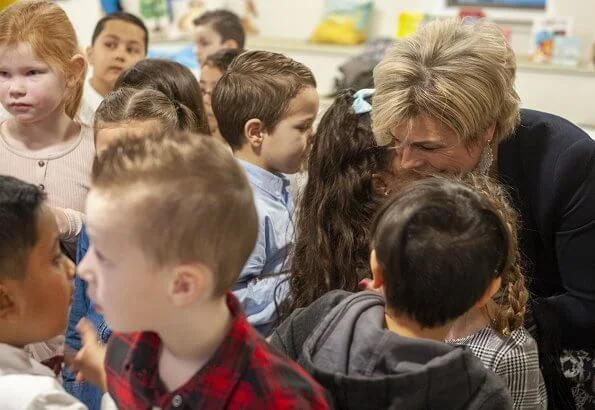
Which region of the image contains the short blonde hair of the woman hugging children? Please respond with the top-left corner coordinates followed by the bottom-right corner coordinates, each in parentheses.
top-left (372, 19), bottom-right (520, 146)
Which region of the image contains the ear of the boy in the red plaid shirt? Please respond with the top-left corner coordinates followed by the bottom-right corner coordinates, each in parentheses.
top-left (168, 264), bottom-right (213, 307)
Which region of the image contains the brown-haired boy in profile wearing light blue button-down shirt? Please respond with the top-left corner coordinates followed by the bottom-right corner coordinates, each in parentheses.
top-left (212, 51), bottom-right (319, 336)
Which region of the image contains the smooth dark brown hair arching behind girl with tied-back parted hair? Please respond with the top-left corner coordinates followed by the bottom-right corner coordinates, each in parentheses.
top-left (115, 59), bottom-right (209, 134)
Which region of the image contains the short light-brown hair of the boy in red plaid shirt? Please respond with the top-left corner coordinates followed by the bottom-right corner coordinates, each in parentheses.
top-left (92, 131), bottom-right (258, 296)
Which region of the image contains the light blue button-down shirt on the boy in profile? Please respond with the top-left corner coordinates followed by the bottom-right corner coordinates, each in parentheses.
top-left (233, 160), bottom-right (293, 335)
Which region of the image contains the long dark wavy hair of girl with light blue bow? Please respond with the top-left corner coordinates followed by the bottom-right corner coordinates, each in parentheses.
top-left (290, 90), bottom-right (390, 310)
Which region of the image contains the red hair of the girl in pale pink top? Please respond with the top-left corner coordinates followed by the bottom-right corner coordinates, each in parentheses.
top-left (0, 0), bottom-right (85, 118)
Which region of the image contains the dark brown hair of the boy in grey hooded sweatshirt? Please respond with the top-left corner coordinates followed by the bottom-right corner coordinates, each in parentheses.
top-left (371, 177), bottom-right (516, 328)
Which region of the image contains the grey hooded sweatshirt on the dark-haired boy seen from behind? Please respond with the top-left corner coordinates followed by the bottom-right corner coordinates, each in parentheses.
top-left (271, 291), bottom-right (512, 410)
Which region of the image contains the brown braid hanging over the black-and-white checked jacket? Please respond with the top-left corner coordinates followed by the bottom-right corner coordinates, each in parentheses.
top-left (463, 173), bottom-right (529, 337)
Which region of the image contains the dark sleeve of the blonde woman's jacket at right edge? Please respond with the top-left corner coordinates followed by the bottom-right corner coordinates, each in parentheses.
top-left (533, 139), bottom-right (595, 348)
